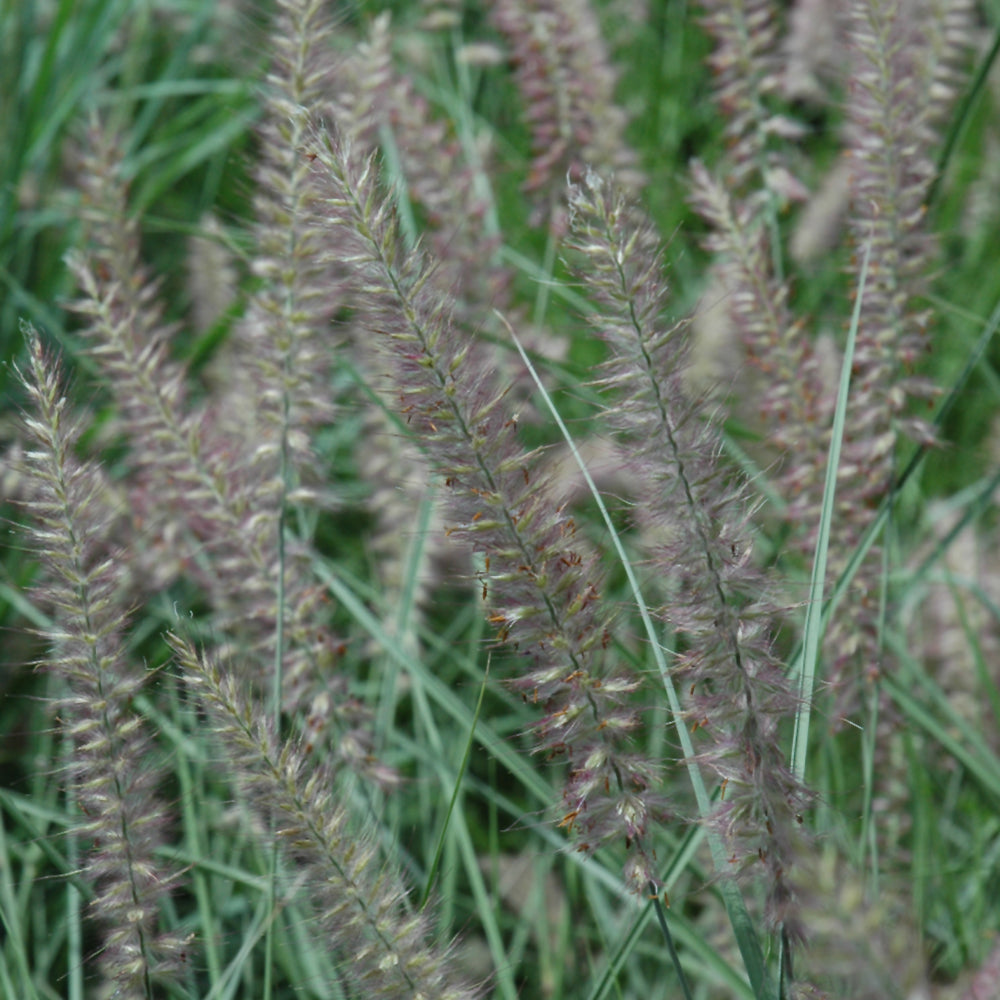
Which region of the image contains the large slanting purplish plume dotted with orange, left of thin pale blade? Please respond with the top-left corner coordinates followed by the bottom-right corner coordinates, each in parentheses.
top-left (314, 127), bottom-right (665, 892)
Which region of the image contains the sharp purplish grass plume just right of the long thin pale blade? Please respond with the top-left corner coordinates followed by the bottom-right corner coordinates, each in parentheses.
top-left (569, 174), bottom-right (808, 928)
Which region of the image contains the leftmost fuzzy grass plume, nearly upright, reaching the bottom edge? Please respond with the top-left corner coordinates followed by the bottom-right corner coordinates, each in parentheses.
top-left (18, 328), bottom-right (182, 1000)
